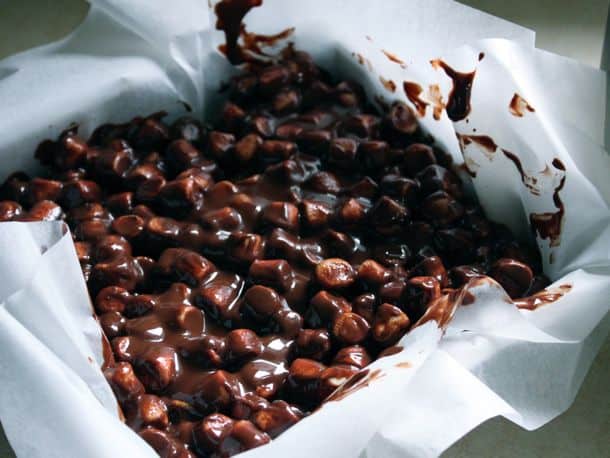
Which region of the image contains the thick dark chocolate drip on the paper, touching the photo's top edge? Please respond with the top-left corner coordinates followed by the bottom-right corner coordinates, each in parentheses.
top-left (214, 0), bottom-right (263, 64)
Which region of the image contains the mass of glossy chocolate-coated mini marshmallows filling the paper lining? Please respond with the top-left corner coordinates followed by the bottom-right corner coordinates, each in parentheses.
top-left (0, 48), bottom-right (548, 458)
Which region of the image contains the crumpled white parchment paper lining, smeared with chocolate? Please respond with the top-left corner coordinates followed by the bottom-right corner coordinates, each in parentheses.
top-left (0, 0), bottom-right (610, 457)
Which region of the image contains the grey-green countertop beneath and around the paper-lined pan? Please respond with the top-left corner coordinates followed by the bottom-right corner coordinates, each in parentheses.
top-left (0, 0), bottom-right (610, 458)
